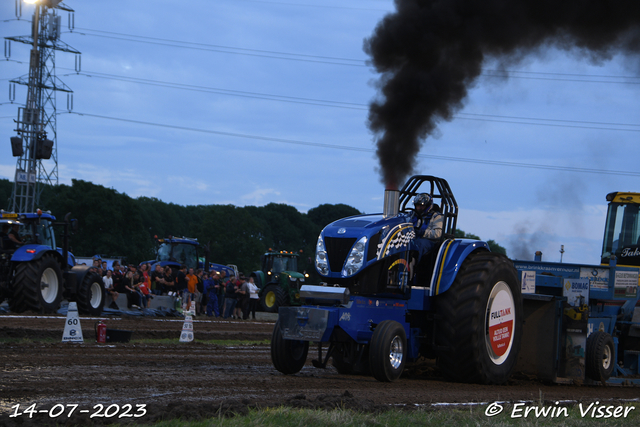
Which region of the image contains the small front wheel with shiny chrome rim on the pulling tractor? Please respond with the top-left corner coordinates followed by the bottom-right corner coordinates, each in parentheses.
top-left (369, 320), bottom-right (407, 382)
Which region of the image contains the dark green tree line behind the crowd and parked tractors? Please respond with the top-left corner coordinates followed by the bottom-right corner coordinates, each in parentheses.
top-left (0, 179), bottom-right (506, 273)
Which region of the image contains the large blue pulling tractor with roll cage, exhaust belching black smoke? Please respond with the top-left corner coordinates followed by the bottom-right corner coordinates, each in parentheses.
top-left (271, 176), bottom-right (522, 383)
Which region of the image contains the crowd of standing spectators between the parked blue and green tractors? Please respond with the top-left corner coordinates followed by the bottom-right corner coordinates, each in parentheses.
top-left (91, 259), bottom-right (259, 320)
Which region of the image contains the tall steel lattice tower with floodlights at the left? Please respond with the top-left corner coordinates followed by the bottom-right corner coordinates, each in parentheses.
top-left (6, 0), bottom-right (80, 212)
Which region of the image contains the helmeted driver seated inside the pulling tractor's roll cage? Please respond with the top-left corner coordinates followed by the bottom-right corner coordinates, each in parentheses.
top-left (410, 193), bottom-right (444, 259)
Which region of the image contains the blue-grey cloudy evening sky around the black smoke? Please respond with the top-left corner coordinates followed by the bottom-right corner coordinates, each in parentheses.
top-left (0, 0), bottom-right (640, 264)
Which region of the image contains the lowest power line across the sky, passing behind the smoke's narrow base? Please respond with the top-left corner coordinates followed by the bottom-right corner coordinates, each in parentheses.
top-left (64, 112), bottom-right (640, 177)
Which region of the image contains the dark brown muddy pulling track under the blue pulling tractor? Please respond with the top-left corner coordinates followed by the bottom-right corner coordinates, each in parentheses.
top-left (0, 314), bottom-right (640, 426)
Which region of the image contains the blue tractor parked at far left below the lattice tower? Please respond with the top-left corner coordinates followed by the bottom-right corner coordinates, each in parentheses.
top-left (0, 210), bottom-right (105, 315)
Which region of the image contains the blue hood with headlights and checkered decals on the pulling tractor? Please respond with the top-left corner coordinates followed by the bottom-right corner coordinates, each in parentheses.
top-left (315, 213), bottom-right (415, 279)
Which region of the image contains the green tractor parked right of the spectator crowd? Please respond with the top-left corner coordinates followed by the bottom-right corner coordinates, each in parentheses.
top-left (251, 250), bottom-right (308, 313)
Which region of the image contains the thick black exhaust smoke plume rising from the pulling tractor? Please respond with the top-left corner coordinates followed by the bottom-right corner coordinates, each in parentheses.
top-left (364, 0), bottom-right (640, 187)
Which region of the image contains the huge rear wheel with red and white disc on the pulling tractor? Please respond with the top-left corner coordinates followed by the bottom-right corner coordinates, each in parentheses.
top-left (436, 252), bottom-right (522, 384)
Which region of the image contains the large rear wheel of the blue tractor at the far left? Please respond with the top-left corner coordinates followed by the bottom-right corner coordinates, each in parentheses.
top-left (9, 255), bottom-right (62, 313)
